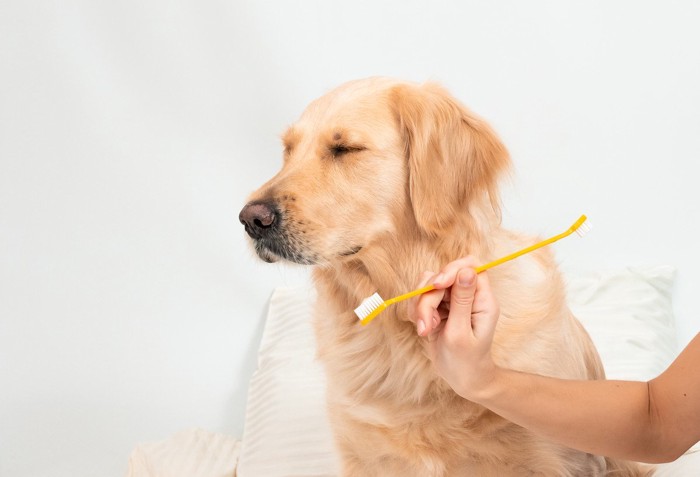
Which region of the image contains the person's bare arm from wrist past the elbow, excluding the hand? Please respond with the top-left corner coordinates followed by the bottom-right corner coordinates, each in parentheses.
top-left (474, 335), bottom-right (700, 462)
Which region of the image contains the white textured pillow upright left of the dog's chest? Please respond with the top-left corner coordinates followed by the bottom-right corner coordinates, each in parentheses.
top-left (237, 288), bottom-right (338, 477)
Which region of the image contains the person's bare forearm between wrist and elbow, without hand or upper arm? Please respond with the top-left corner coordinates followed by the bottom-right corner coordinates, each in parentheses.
top-left (467, 368), bottom-right (664, 462)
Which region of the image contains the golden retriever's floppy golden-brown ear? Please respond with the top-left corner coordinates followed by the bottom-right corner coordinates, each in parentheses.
top-left (391, 83), bottom-right (510, 235)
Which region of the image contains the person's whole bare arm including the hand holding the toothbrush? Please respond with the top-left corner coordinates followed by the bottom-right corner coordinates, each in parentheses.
top-left (416, 258), bottom-right (700, 462)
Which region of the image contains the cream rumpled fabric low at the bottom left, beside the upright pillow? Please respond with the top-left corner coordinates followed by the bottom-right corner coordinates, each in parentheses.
top-left (126, 429), bottom-right (240, 477)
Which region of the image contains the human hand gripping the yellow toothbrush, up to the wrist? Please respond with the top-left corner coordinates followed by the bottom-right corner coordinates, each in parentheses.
top-left (415, 256), bottom-right (500, 400)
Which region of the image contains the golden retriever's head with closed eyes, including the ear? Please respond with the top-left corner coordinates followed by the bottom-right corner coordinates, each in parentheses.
top-left (239, 78), bottom-right (509, 265)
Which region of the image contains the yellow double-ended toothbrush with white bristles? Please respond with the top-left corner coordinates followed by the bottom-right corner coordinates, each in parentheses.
top-left (355, 215), bottom-right (591, 326)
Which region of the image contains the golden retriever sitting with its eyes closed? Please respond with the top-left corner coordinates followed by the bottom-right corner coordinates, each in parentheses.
top-left (239, 78), bottom-right (650, 477)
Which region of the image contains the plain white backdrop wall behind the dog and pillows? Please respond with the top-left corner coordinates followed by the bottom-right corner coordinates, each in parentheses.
top-left (0, 0), bottom-right (700, 477)
